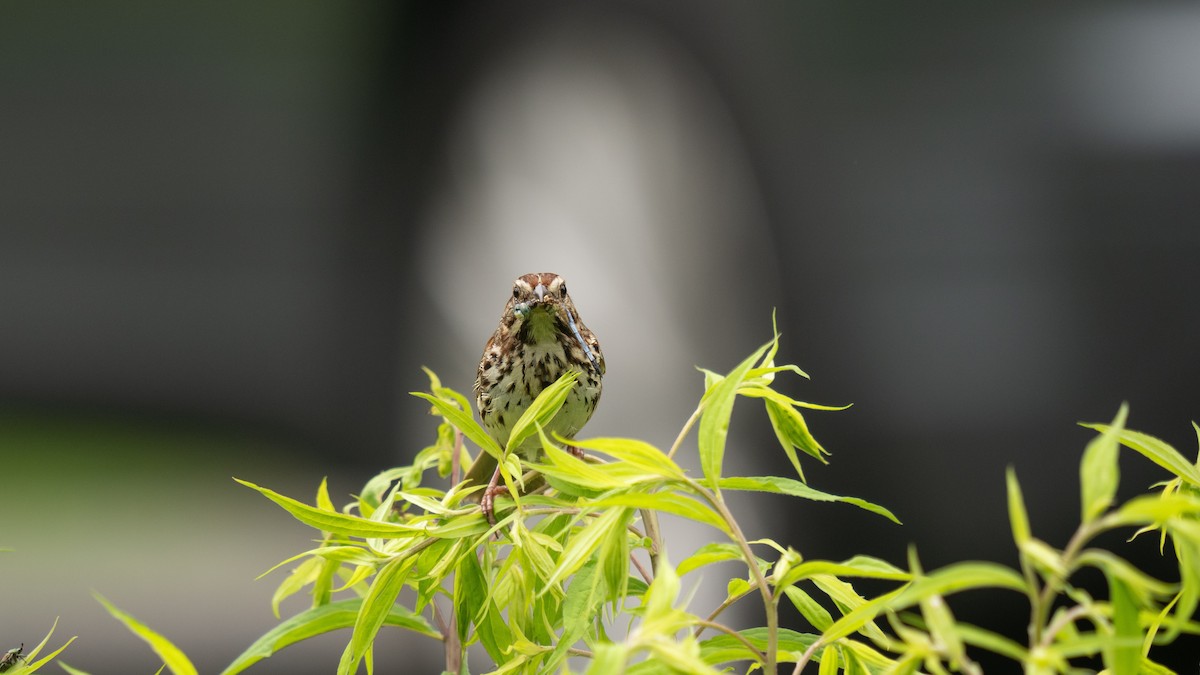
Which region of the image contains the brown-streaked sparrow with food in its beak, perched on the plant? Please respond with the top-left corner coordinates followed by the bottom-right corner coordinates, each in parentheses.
top-left (466, 271), bottom-right (605, 520)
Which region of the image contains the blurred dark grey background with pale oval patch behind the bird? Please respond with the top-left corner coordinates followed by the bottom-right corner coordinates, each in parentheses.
top-left (0, 1), bottom-right (1200, 674)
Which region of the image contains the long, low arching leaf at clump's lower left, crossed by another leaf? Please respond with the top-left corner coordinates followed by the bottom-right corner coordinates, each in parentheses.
top-left (221, 598), bottom-right (442, 675)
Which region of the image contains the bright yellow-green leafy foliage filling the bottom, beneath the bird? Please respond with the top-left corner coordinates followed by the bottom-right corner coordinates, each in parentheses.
top-left (84, 324), bottom-right (1200, 675)
